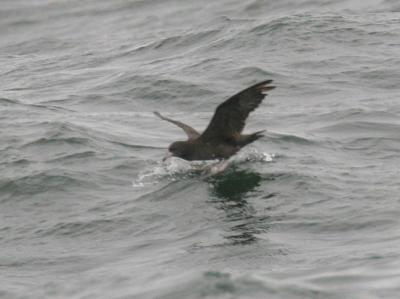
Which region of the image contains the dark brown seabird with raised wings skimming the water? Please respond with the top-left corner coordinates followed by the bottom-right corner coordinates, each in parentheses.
top-left (154, 80), bottom-right (275, 161)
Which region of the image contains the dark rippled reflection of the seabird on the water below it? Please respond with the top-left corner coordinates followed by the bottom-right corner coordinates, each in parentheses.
top-left (209, 169), bottom-right (267, 245)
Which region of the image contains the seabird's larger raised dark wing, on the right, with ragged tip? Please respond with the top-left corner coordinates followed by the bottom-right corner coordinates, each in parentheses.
top-left (200, 80), bottom-right (275, 142)
